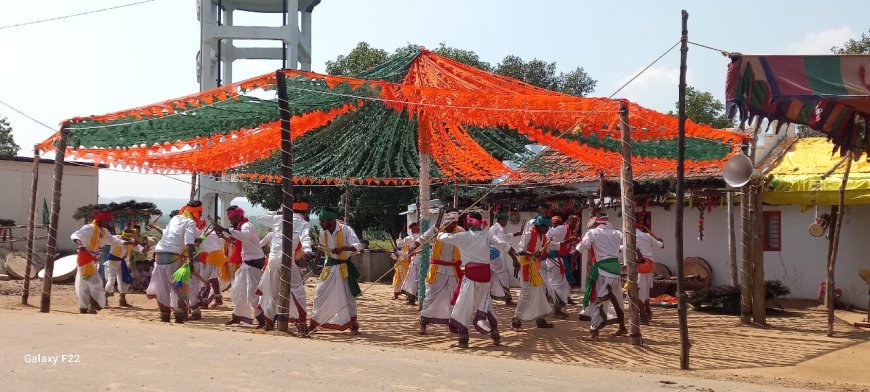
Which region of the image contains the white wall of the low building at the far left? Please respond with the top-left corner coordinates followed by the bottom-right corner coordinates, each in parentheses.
top-left (0, 160), bottom-right (99, 252)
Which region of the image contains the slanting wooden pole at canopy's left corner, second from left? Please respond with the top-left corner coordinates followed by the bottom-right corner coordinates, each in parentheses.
top-left (39, 122), bottom-right (69, 313)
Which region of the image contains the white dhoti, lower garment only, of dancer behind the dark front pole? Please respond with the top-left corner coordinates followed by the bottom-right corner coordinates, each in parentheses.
top-left (257, 262), bottom-right (307, 323)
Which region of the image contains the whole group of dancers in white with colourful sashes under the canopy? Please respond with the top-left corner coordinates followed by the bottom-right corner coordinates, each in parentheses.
top-left (72, 201), bottom-right (663, 347)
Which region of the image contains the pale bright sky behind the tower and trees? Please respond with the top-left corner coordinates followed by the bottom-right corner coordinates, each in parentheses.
top-left (0, 0), bottom-right (870, 198)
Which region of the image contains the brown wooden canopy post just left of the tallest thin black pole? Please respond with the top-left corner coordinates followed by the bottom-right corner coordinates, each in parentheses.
top-left (619, 102), bottom-right (642, 346)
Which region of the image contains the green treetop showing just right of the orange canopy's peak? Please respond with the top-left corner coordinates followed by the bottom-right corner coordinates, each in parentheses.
top-left (494, 55), bottom-right (597, 97)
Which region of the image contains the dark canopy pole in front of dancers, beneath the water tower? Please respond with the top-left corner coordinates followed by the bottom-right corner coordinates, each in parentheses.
top-left (275, 70), bottom-right (295, 333)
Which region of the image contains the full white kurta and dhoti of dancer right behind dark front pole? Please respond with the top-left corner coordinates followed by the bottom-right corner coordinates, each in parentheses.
top-left (257, 213), bottom-right (311, 323)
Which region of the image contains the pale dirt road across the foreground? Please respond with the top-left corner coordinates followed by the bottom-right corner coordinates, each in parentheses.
top-left (0, 311), bottom-right (816, 392)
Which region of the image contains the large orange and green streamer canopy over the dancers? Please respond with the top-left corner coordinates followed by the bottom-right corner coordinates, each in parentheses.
top-left (40, 50), bottom-right (744, 185)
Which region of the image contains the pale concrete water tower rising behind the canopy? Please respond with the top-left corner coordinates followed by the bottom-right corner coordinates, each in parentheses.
top-left (196, 0), bottom-right (320, 222)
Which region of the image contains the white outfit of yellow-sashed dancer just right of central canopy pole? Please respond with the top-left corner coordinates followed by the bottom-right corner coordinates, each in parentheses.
top-left (420, 226), bottom-right (464, 324)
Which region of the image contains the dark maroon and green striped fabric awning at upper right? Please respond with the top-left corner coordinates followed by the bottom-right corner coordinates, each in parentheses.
top-left (725, 55), bottom-right (870, 155)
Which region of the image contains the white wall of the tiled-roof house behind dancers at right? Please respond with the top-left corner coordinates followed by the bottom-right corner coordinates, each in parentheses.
top-left (498, 205), bottom-right (870, 308)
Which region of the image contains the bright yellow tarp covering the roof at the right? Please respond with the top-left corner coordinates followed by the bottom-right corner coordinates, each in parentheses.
top-left (764, 138), bottom-right (870, 206)
